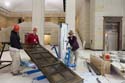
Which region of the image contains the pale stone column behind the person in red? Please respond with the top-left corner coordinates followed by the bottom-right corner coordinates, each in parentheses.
top-left (32, 0), bottom-right (45, 45)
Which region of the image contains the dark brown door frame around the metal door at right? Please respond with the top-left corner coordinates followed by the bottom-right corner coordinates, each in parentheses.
top-left (103, 16), bottom-right (123, 50)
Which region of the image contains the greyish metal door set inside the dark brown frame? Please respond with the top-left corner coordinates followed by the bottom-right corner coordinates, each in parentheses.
top-left (105, 22), bottom-right (119, 51)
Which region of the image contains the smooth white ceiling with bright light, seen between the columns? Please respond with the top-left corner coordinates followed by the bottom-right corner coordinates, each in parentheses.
top-left (0, 0), bottom-right (63, 12)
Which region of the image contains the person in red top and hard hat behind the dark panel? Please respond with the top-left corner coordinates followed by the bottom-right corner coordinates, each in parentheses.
top-left (26, 27), bottom-right (39, 44)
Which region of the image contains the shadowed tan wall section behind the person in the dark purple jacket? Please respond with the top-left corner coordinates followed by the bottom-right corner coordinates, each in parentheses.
top-left (77, 0), bottom-right (90, 48)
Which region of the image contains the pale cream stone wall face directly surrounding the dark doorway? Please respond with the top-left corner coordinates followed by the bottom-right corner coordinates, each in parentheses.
top-left (90, 0), bottom-right (125, 49)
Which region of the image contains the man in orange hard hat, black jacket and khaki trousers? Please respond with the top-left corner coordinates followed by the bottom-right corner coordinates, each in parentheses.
top-left (10, 24), bottom-right (22, 75)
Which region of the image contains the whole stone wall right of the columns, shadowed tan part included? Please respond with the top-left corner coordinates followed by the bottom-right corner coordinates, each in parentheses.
top-left (76, 0), bottom-right (125, 50)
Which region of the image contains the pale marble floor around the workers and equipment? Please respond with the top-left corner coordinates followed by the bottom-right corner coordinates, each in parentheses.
top-left (0, 47), bottom-right (125, 83)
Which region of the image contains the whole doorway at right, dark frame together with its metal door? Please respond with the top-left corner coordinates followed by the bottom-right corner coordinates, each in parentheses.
top-left (103, 17), bottom-right (122, 51)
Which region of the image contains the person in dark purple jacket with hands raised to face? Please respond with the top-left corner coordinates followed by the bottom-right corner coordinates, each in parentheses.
top-left (68, 30), bottom-right (79, 64)
